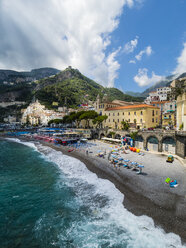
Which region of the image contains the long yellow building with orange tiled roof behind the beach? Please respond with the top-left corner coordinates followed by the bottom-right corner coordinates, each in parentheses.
top-left (102, 104), bottom-right (160, 129)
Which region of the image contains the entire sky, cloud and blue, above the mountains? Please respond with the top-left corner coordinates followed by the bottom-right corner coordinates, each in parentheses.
top-left (0, 0), bottom-right (186, 92)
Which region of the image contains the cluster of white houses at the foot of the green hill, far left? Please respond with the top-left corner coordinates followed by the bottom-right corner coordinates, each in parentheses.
top-left (21, 100), bottom-right (66, 125)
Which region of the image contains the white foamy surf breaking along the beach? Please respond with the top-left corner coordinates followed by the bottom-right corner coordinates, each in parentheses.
top-left (8, 139), bottom-right (186, 248)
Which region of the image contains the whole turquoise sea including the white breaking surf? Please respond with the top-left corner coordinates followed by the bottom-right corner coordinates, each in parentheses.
top-left (0, 139), bottom-right (186, 248)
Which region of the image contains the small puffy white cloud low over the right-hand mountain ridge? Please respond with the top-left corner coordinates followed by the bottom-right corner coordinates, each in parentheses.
top-left (134, 68), bottom-right (164, 87)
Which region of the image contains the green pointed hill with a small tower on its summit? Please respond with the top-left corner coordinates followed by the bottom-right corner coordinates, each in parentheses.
top-left (34, 67), bottom-right (143, 108)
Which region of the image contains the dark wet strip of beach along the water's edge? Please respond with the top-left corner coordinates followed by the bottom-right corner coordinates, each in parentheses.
top-left (2, 137), bottom-right (186, 244)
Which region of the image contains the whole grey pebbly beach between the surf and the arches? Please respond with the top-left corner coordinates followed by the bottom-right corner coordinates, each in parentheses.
top-left (1, 139), bottom-right (186, 243)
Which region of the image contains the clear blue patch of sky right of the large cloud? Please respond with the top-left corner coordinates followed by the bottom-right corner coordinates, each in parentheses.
top-left (111, 0), bottom-right (186, 92)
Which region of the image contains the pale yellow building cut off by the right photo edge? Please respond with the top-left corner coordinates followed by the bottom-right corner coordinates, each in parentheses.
top-left (176, 92), bottom-right (186, 131)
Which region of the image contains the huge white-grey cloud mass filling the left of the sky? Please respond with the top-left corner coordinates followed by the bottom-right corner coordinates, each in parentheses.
top-left (0, 0), bottom-right (140, 86)
